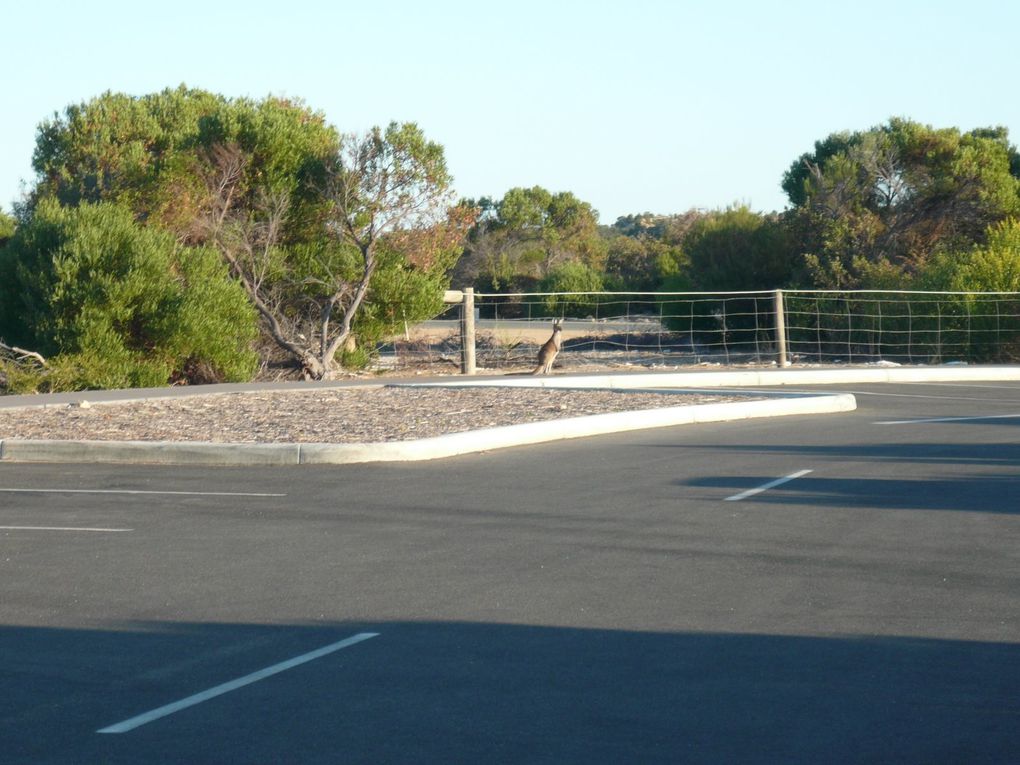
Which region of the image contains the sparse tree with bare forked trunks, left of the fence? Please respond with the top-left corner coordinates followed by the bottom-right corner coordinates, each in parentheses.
top-left (204, 122), bottom-right (463, 379)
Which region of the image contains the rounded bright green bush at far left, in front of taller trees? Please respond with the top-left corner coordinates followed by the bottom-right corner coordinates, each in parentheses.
top-left (0, 200), bottom-right (255, 389)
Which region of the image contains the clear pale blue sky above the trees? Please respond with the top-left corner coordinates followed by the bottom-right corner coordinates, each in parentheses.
top-left (0, 0), bottom-right (1020, 223)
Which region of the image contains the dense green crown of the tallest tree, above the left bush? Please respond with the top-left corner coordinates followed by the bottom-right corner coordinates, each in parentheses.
top-left (33, 86), bottom-right (338, 233)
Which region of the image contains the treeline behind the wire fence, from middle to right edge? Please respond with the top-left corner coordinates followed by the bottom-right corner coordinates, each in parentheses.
top-left (453, 119), bottom-right (1020, 312)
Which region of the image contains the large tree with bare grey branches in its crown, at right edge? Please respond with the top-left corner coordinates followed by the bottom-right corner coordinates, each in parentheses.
top-left (782, 119), bottom-right (1020, 287)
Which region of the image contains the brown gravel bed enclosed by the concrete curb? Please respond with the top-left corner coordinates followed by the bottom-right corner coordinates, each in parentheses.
top-left (0, 387), bottom-right (748, 444)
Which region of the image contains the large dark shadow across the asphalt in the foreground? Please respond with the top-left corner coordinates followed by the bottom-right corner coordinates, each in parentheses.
top-left (0, 622), bottom-right (1020, 764)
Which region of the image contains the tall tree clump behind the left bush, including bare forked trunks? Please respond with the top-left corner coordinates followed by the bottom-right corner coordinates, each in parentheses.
top-left (29, 87), bottom-right (462, 376)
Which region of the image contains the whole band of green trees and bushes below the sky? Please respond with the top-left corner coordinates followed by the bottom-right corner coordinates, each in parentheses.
top-left (0, 87), bottom-right (1020, 391)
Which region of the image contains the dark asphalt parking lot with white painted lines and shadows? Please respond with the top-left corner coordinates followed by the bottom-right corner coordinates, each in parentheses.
top-left (0, 383), bottom-right (1020, 763)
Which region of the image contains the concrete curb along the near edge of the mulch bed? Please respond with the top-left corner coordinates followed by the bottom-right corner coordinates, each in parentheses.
top-left (0, 394), bottom-right (857, 466)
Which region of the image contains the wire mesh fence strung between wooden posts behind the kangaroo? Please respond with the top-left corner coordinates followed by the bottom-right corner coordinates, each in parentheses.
top-left (379, 290), bottom-right (1020, 371)
